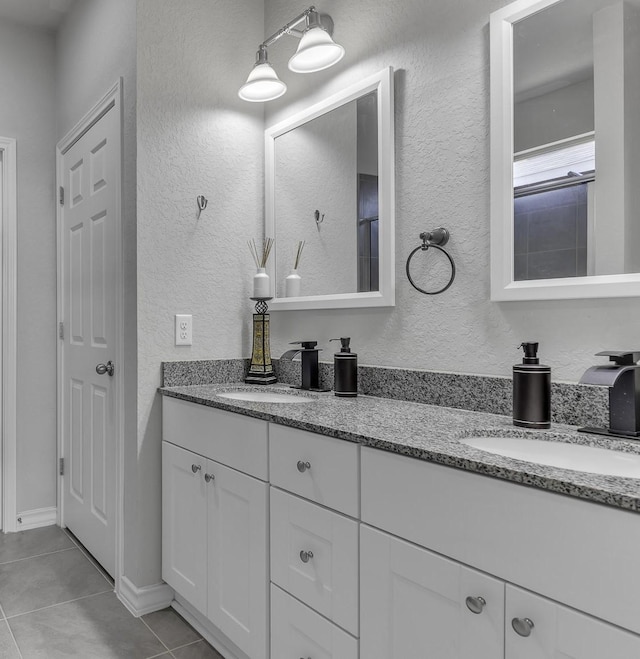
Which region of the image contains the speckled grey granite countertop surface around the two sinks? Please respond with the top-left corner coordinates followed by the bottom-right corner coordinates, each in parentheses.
top-left (159, 384), bottom-right (640, 512)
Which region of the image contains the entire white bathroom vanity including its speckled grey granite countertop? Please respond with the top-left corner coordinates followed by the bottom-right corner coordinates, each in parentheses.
top-left (162, 385), bottom-right (640, 659)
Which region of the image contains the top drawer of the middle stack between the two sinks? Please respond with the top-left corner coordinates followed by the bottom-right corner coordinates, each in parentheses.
top-left (269, 424), bottom-right (360, 517)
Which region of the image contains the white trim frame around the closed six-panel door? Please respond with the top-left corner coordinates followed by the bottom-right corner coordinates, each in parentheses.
top-left (56, 78), bottom-right (124, 593)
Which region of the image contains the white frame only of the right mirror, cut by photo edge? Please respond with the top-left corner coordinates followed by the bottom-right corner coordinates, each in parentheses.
top-left (490, 0), bottom-right (640, 302)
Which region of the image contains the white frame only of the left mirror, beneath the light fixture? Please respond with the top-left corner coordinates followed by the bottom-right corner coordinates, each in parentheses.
top-left (265, 67), bottom-right (396, 311)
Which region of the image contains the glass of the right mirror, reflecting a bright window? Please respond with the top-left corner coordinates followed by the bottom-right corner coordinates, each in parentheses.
top-left (513, 0), bottom-right (640, 281)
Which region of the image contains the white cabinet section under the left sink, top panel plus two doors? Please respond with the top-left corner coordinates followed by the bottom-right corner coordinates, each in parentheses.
top-left (162, 399), bottom-right (269, 659)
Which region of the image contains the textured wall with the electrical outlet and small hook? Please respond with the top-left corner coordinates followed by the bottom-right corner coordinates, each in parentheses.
top-left (133, 0), bottom-right (264, 586)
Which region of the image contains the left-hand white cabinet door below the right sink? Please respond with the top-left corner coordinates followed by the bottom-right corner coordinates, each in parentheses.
top-left (360, 525), bottom-right (504, 659)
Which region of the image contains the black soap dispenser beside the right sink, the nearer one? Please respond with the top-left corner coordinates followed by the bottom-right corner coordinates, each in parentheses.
top-left (513, 341), bottom-right (551, 428)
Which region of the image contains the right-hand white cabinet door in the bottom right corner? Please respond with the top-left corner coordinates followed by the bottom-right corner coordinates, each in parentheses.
top-left (505, 585), bottom-right (640, 659)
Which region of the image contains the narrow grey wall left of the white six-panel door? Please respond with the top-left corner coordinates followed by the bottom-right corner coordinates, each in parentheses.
top-left (0, 22), bottom-right (56, 512)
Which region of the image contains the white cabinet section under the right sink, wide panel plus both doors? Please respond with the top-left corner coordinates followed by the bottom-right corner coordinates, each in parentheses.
top-left (360, 448), bottom-right (640, 659)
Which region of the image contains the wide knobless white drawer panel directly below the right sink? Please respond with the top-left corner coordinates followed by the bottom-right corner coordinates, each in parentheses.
top-left (362, 448), bottom-right (640, 632)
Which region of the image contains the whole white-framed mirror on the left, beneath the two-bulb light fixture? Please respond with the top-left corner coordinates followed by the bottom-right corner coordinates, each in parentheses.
top-left (265, 68), bottom-right (395, 310)
